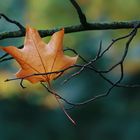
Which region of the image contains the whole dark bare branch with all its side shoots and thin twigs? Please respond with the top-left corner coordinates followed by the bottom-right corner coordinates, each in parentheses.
top-left (0, 0), bottom-right (140, 111)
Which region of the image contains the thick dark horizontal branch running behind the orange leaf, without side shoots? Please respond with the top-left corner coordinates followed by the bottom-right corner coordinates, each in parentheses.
top-left (0, 21), bottom-right (140, 40)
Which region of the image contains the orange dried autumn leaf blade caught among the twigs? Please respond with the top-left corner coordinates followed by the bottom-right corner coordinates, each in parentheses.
top-left (2, 26), bottom-right (78, 83)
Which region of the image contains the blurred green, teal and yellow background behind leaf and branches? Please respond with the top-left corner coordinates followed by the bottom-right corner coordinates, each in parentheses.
top-left (0, 0), bottom-right (140, 140)
